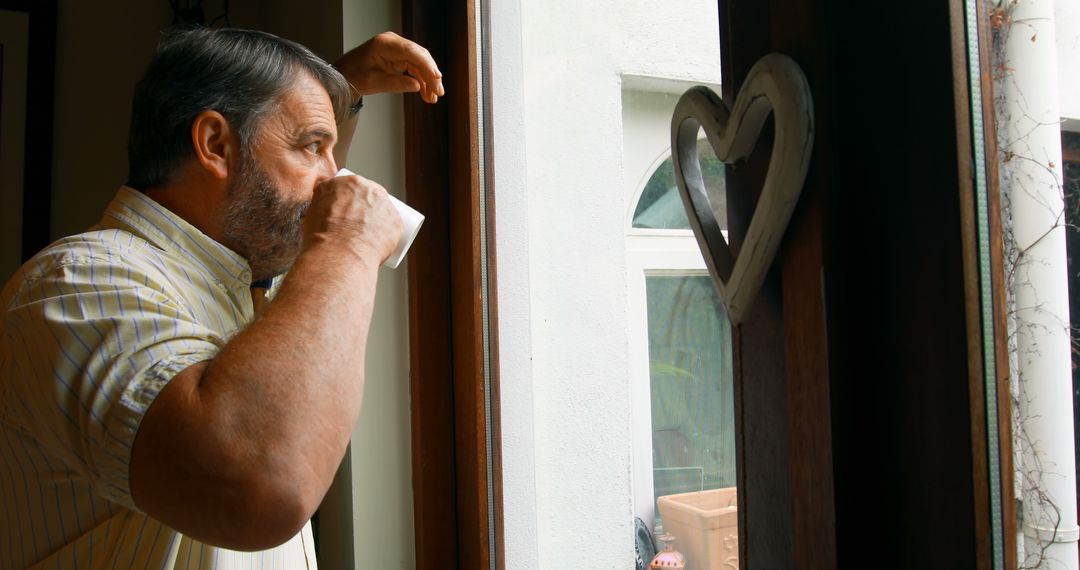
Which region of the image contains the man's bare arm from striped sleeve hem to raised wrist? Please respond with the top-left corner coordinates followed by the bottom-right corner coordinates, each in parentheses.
top-left (132, 242), bottom-right (381, 549)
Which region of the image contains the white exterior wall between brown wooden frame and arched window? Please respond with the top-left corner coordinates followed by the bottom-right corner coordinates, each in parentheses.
top-left (491, 0), bottom-right (719, 569)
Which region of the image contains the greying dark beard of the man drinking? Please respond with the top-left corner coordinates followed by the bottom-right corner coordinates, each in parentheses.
top-left (221, 151), bottom-right (310, 281)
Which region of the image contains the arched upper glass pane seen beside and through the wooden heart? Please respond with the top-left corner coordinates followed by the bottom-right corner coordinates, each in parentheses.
top-left (633, 146), bottom-right (728, 230)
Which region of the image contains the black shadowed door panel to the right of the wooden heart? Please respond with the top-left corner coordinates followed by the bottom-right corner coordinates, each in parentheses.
top-left (826, 2), bottom-right (977, 568)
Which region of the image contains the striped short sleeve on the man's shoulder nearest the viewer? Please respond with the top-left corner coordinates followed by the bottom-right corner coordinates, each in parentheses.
top-left (2, 248), bottom-right (226, 511)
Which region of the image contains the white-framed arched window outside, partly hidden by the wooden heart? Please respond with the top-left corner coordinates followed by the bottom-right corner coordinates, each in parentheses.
top-left (626, 136), bottom-right (735, 529)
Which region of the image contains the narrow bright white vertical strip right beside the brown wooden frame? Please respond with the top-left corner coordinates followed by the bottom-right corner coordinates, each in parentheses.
top-left (488, 0), bottom-right (544, 570)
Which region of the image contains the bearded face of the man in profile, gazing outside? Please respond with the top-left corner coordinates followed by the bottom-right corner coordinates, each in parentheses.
top-left (221, 73), bottom-right (337, 280)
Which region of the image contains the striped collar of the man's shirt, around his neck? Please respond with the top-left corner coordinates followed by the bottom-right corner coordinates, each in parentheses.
top-left (100, 186), bottom-right (252, 287)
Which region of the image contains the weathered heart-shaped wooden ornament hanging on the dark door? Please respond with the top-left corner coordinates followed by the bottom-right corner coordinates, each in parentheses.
top-left (672, 54), bottom-right (813, 325)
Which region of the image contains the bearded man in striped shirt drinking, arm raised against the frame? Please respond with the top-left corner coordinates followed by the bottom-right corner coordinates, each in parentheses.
top-left (0, 25), bottom-right (443, 569)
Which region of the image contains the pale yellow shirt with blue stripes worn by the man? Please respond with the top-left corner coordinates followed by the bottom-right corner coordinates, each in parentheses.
top-left (0, 188), bottom-right (315, 570)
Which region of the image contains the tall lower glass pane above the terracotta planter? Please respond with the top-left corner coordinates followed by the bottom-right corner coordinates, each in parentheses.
top-left (646, 275), bottom-right (735, 530)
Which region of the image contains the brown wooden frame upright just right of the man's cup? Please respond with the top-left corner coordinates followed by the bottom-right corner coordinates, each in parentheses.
top-left (403, 0), bottom-right (504, 569)
